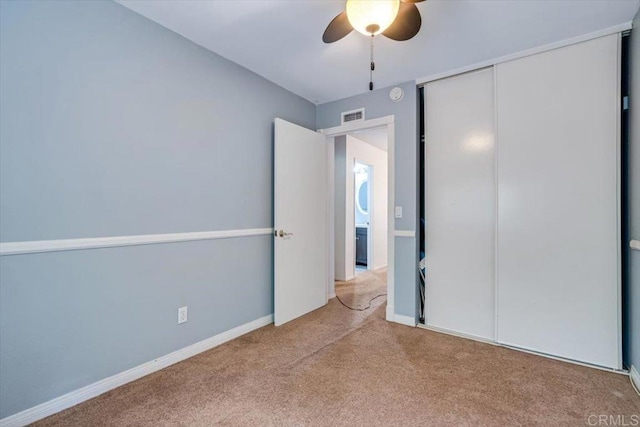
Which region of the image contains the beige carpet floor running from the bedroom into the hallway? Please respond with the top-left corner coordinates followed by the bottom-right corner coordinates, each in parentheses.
top-left (37, 271), bottom-right (640, 426)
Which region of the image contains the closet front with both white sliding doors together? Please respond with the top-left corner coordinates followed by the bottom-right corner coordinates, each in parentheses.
top-left (424, 34), bottom-right (621, 368)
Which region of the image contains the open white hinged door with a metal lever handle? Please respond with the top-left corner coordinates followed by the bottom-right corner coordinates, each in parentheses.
top-left (274, 119), bottom-right (329, 326)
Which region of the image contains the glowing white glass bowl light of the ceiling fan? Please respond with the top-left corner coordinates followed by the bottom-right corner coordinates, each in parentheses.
top-left (346, 0), bottom-right (400, 36)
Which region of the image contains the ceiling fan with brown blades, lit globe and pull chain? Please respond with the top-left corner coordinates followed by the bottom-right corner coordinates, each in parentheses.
top-left (322, 0), bottom-right (424, 90)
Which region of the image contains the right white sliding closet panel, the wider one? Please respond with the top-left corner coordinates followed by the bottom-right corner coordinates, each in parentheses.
top-left (496, 35), bottom-right (620, 368)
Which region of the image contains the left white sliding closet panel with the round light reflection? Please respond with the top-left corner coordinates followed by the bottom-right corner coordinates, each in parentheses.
top-left (425, 68), bottom-right (496, 339)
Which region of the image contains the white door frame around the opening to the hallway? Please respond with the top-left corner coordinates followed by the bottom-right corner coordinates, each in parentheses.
top-left (317, 114), bottom-right (395, 322)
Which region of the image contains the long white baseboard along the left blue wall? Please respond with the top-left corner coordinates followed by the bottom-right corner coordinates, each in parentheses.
top-left (0, 314), bottom-right (273, 427)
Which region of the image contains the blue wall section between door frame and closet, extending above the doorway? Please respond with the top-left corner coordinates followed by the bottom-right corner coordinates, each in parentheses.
top-left (316, 81), bottom-right (418, 317)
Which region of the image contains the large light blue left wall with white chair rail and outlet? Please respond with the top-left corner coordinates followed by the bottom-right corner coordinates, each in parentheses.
top-left (0, 1), bottom-right (316, 418)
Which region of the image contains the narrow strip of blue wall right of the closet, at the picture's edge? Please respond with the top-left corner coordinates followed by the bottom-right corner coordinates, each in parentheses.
top-left (623, 10), bottom-right (640, 371)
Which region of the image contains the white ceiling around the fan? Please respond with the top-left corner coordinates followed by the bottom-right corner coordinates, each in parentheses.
top-left (117, 0), bottom-right (640, 103)
